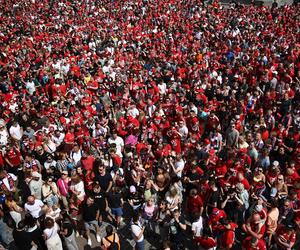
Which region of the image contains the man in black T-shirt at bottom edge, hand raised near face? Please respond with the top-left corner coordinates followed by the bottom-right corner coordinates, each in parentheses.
top-left (169, 209), bottom-right (186, 250)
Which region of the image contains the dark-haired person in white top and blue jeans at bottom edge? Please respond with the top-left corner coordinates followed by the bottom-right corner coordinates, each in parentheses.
top-left (131, 212), bottom-right (145, 250)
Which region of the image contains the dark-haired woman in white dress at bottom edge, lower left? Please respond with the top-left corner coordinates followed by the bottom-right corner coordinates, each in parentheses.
top-left (43, 217), bottom-right (63, 250)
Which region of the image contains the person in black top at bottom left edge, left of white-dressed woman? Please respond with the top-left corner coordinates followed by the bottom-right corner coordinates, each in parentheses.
top-left (13, 220), bottom-right (36, 250)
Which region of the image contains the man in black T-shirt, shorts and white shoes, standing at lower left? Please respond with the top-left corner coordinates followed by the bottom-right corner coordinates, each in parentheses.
top-left (82, 196), bottom-right (101, 246)
